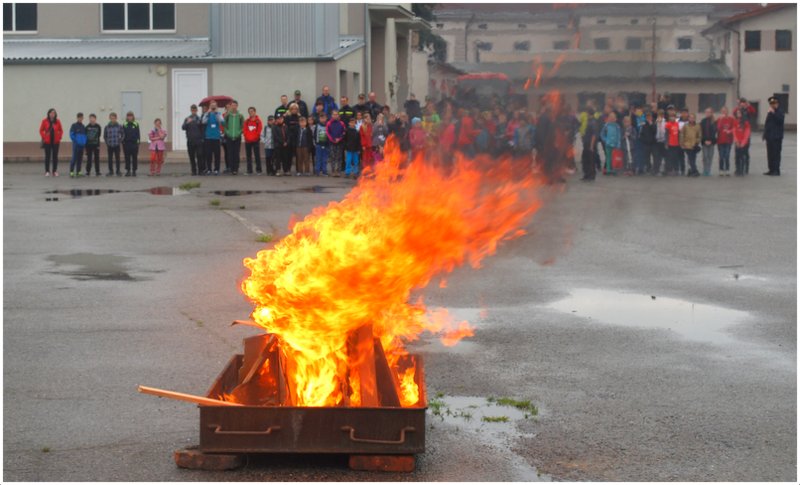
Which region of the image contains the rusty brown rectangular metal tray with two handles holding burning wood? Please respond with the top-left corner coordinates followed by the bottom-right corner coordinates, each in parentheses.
top-left (200, 342), bottom-right (427, 455)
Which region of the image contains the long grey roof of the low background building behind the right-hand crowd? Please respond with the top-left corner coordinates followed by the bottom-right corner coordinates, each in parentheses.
top-left (451, 61), bottom-right (733, 81)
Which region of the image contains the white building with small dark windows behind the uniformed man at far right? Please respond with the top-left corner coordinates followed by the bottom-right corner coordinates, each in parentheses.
top-left (703, 3), bottom-right (797, 128)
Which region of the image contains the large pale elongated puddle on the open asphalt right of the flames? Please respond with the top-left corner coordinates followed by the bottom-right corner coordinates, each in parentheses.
top-left (547, 289), bottom-right (748, 343)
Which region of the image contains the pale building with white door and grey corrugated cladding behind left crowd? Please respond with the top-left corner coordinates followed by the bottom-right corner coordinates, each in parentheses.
top-left (3, 3), bottom-right (429, 160)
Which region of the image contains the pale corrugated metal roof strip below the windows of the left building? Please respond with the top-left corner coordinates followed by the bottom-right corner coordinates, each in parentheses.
top-left (3, 38), bottom-right (210, 63)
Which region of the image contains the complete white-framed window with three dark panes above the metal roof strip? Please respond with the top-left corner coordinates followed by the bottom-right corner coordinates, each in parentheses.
top-left (101, 3), bottom-right (175, 32)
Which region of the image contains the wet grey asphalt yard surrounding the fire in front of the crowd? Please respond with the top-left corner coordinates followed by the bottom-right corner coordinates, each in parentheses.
top-left (3, 135), bottom-right (797, 481)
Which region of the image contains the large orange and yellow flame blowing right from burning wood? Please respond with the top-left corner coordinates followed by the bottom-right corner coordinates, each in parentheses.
top-left (242, 138), bottom-right (542, 406)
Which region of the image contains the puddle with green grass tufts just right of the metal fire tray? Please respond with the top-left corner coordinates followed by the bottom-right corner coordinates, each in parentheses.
top-left (428, 396), bottom-right (552, 481)
